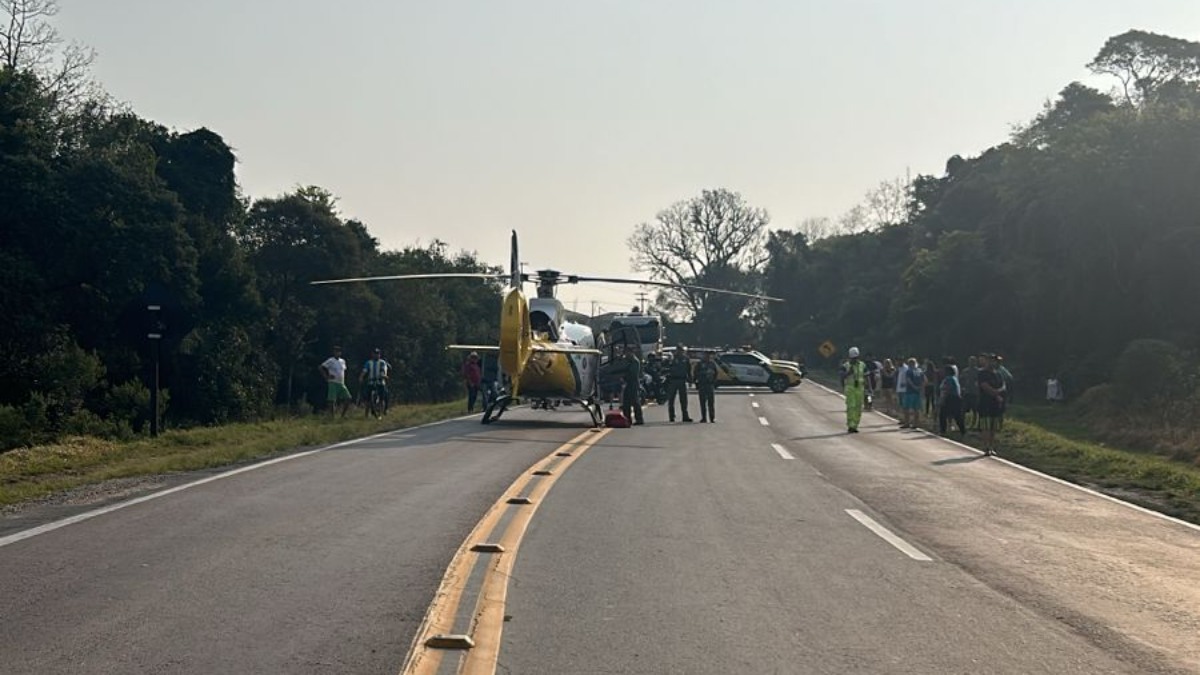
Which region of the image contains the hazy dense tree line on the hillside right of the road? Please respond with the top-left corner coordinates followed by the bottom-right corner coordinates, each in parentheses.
top-left (764, 31), bottom-right (1200, 403)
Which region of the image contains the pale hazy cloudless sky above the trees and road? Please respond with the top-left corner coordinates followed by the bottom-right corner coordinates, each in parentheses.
top-left (58, 0), bottom-right (1200, 310)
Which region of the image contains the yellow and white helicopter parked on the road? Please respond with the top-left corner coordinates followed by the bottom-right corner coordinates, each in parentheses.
top-left (311, 231), bottom-right (779, 426)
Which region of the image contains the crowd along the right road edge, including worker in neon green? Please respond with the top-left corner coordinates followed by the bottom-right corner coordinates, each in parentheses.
top-left (842, 348), bottom-right (1013, 454)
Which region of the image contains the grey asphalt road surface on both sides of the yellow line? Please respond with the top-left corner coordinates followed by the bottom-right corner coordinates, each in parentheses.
top-left (0, 384), bottom-right (1200, 674)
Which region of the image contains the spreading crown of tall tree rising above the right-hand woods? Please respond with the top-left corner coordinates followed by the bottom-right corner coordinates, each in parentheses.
top-left (1087, 30), bottom-right (1200, 106)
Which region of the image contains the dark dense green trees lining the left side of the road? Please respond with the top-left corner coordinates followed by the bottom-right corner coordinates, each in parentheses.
top-left (0, 66), bottom-right (497, 447)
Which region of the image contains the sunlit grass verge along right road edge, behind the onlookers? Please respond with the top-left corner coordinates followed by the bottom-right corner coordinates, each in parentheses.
top-left (811, 371), bottom-right (1200, 524)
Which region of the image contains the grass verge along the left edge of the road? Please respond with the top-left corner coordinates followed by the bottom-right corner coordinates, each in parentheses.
top-left (0, 400), bottom-right (466, 506)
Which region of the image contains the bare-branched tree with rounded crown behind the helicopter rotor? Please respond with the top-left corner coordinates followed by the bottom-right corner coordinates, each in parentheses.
top-left (628, 189), bottom-right (770, 340)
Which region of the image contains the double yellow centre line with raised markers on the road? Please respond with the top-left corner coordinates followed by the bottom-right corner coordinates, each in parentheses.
top-left (401, 429), bottom-right (610, 675)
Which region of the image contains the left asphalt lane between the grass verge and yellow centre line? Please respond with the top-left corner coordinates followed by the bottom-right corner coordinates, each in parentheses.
top-left (0, 411), bottom-right (586, 675)
